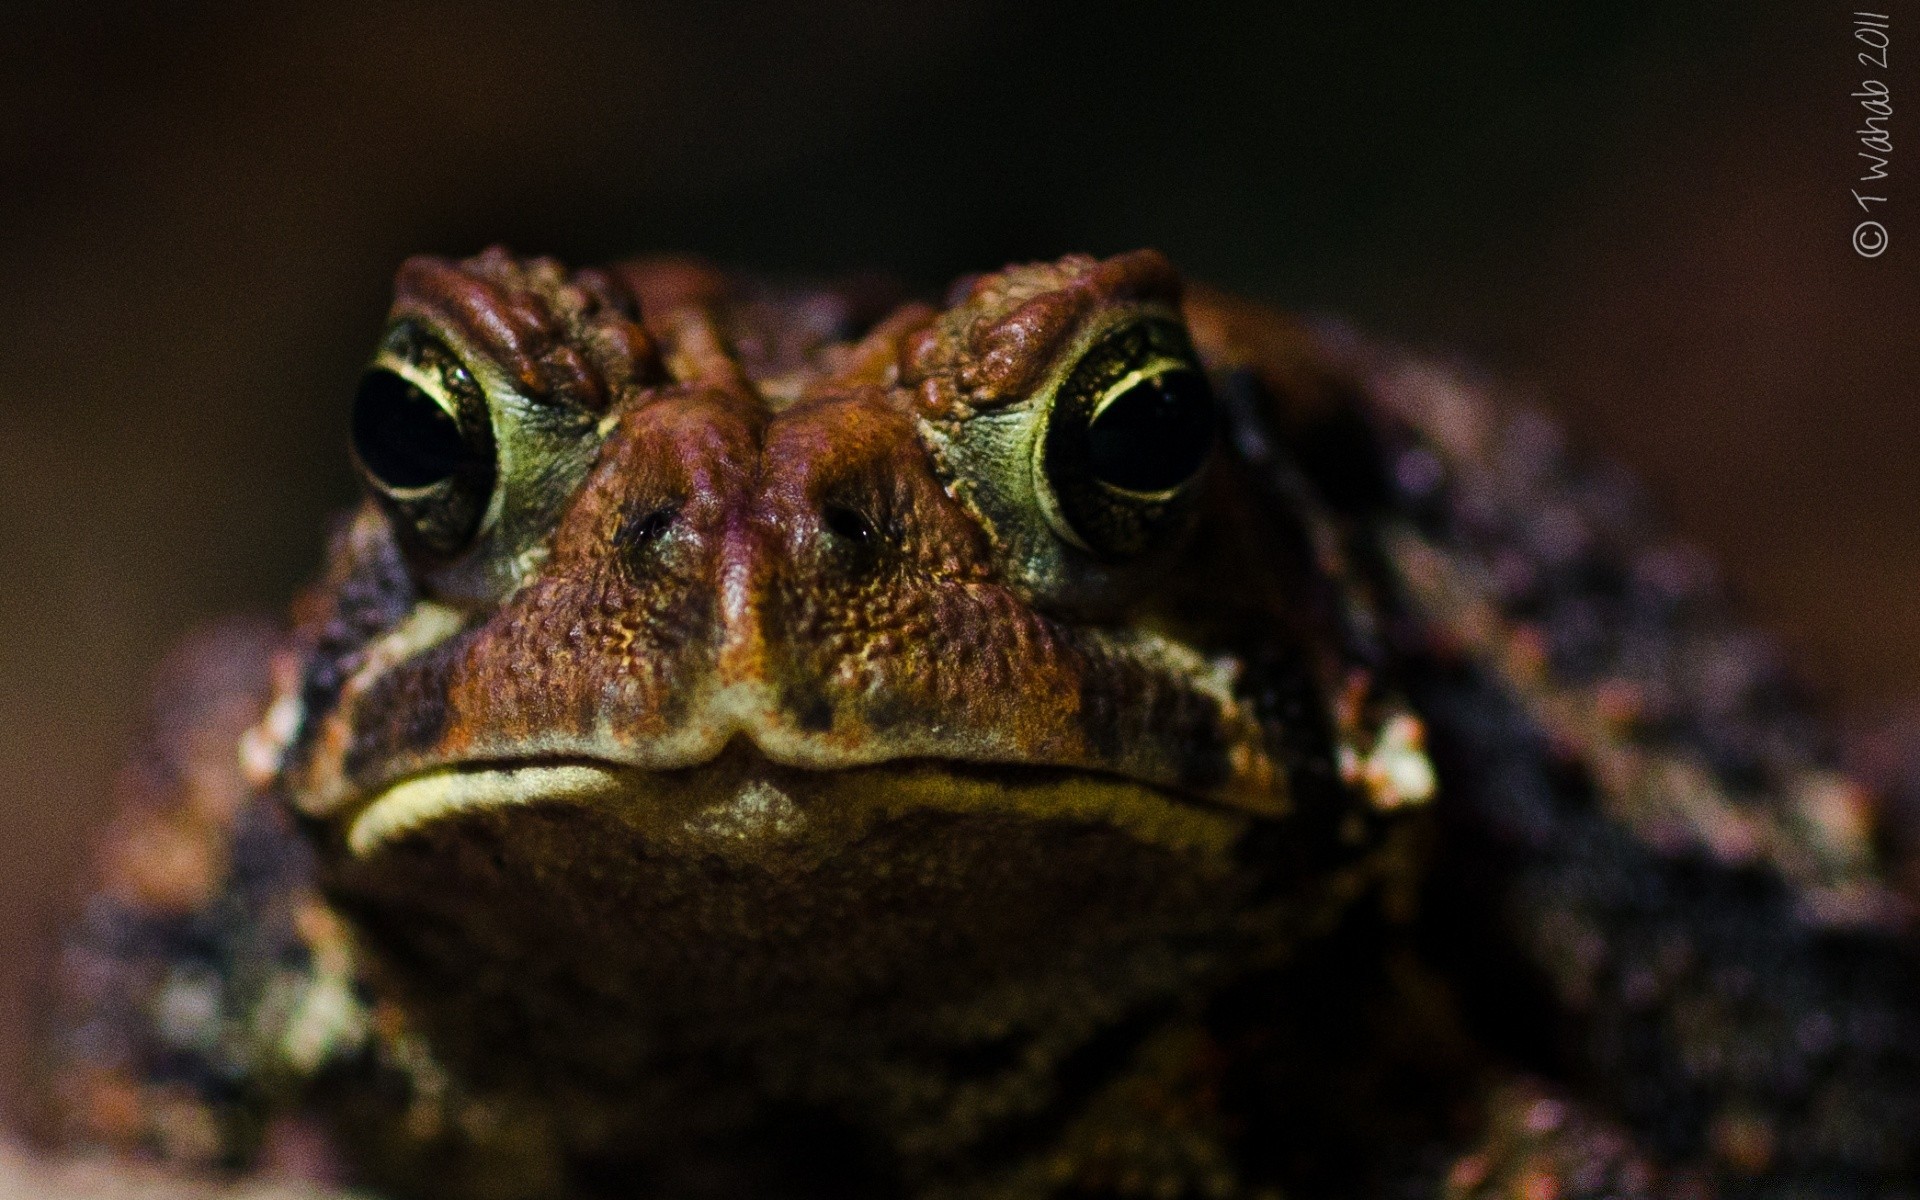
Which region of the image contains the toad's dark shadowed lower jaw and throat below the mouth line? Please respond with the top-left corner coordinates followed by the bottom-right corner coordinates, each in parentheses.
top-left (324, 745), bottom-right (1320, 1105)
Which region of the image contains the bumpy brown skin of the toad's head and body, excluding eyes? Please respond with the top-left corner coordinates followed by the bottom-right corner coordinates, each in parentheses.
top-left (26, 252), bottom-right (1920, 1200)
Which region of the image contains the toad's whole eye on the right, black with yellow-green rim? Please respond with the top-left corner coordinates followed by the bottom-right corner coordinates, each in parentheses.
top-left (1033, 319), bottom-right (1215, 559)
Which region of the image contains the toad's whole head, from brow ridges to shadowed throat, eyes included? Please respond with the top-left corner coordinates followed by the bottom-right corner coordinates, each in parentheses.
top-left (269, 252), bottom-right (1420, 1121)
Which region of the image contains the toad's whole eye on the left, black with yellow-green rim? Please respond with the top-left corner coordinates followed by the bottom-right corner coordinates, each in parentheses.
top-left (353, 344), bottom-right (495, 559)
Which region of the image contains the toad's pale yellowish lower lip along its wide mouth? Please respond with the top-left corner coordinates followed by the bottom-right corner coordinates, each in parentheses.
top-left (346, 756), bottom-right (1279, 858)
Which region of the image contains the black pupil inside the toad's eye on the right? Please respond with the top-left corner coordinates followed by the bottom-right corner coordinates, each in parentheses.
top-left (1087, 371), bottom-right (1213, 492)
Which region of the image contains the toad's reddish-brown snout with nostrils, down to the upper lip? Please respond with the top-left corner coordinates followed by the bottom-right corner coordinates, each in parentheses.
top-left (284, 390), bottom-right (1284, 833)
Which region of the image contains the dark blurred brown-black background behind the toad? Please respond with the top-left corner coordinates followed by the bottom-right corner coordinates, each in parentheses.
top-left (0, 0), bottom-right (1920, 1102)
